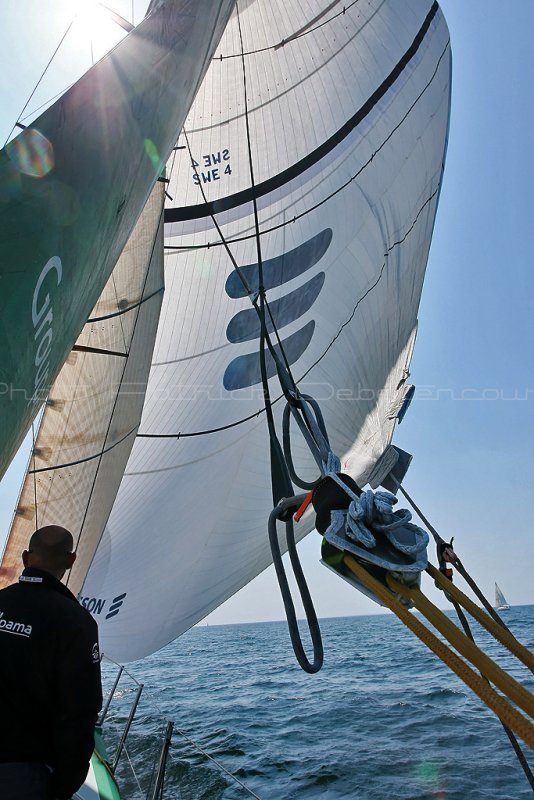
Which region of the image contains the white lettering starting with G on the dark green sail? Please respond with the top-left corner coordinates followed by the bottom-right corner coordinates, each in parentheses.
top-left (28, 256), bottom-right (63, 405)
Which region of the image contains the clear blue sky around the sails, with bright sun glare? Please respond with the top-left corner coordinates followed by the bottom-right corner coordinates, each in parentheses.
top-left (0, 0), bottom-right (534, 624)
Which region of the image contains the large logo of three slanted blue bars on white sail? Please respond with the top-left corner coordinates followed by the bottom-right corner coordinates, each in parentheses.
top-left (223, 228), bottom-right (332, 391)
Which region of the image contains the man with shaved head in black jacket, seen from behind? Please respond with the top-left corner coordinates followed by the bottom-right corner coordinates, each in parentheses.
top-left (0, 525), bottom-right (102, 800)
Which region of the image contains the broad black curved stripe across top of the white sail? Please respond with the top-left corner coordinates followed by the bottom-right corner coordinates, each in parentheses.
top-left (168, 2), bottom-right (439, 223)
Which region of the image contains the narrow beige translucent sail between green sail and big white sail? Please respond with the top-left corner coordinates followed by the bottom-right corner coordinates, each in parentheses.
top-left (0, 181), bottom-right (165, 591)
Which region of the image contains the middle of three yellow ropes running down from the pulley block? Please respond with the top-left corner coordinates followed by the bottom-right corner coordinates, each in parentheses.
top-left (387, 575), bottom-right (534, 717)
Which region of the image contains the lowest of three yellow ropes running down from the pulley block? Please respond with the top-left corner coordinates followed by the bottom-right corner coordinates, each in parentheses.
top-left (343, 554), bottom-right (534, 750)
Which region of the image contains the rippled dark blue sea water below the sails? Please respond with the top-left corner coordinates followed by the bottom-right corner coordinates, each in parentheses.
top-left (101, 606), bottom-right (534, 800)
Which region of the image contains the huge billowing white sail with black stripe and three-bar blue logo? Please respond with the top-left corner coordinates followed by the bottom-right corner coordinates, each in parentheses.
top-left (82, 0), bottom-right (450, 660)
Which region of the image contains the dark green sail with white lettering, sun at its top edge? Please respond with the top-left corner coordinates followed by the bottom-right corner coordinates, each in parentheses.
top-left (0, 0), bottom-right (237, 477)
